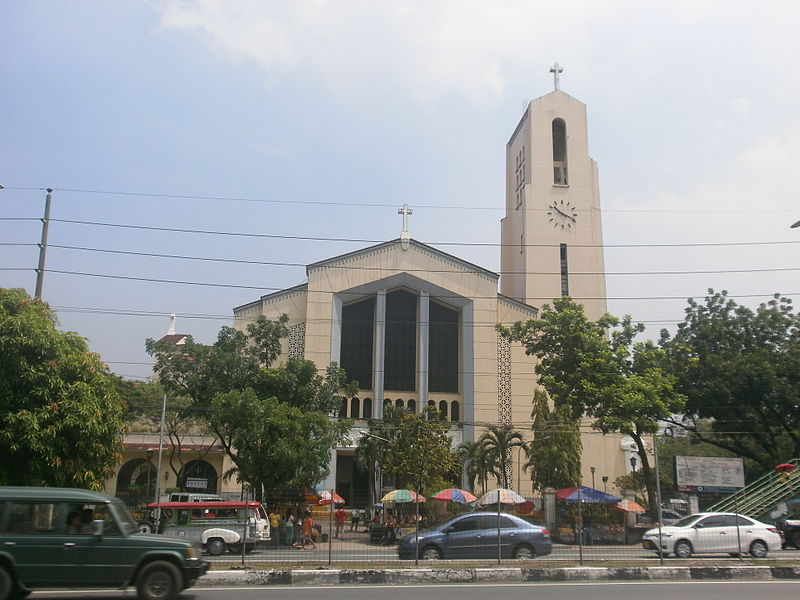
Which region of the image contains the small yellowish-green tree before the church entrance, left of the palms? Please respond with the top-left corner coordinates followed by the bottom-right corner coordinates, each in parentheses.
top-left (385, 413), bottom-right (458, 489)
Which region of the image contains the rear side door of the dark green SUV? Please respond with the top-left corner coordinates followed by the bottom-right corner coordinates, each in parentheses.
top-left (0, 500), bottom-right (74, 587)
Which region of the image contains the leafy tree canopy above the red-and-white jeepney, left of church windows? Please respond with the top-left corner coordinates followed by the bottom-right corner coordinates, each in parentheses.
top-left (146, 315), bottom-right (355, 497)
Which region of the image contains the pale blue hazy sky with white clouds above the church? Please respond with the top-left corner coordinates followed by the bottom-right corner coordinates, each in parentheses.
top-left (0, 0), bottom-right (800, 379)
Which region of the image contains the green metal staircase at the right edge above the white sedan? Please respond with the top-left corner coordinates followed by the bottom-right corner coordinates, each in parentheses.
top-left (707, 458), bottom-right (800, 519)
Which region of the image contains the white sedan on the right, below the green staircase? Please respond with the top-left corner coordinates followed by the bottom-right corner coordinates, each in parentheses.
top-left (642, 513), bottom-right (781, 558)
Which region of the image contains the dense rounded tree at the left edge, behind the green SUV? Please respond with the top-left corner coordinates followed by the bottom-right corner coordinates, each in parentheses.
top-left (0, 288), bottom-right (124, 490)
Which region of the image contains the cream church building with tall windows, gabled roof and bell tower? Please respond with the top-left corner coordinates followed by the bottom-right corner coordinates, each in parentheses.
top-left (234, 64), bottom-right (626, 507)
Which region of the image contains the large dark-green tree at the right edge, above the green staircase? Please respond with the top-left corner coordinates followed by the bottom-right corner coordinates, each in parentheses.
top-left (661, 290), bottom-right (800, 471)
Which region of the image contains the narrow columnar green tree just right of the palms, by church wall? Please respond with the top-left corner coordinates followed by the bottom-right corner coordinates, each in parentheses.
top-left (524, 389), bottom-right (583, 491)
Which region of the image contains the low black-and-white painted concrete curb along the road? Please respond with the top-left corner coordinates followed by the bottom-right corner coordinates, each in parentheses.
top-left (198, 565), bottom-right (800, 587)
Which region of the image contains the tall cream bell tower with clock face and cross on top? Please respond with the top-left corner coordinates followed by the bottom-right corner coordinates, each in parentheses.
top-left (500, 63), bottom-right (607, 319)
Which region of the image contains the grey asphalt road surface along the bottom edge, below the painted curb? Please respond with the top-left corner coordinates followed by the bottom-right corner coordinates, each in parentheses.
top-left (23, 581), bottom-right (800, 600)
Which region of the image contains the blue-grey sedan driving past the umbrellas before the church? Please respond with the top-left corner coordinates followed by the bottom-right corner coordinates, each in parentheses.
top-left (397, 512), bottom-right (553, 560)
